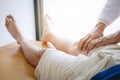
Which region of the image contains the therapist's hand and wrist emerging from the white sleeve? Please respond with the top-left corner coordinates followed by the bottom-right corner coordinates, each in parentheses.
top-left (78, 23), bottom-right (106, 53)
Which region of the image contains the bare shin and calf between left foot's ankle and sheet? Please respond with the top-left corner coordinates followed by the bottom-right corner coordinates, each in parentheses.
top-left (20, 40), bottom-right (46, 67)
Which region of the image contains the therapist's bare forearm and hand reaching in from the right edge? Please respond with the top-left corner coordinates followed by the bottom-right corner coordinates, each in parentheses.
top-left (86, 32), bottom-right (120, 53)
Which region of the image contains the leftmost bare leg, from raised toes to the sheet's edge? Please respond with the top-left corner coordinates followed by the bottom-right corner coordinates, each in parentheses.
top-left (5, 15), bottom-right (45, 67)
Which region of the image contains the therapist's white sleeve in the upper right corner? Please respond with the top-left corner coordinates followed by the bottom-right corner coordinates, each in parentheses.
top-left (98, 0), bottom-right (120, 25)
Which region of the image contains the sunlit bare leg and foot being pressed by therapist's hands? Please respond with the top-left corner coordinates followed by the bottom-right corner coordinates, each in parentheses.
top-left (41, 15), bottom-right (80, 55)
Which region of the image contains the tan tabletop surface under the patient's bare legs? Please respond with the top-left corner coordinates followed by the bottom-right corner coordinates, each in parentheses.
top-left (0, 41), bottom-right (52, 80)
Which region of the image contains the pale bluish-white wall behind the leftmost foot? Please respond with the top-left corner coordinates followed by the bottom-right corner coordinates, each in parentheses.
top-left (0, 0), bottom-right (35, 46)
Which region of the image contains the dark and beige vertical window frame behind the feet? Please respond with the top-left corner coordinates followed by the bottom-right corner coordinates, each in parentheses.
top-left (34, 0), bottom-right (44, 40)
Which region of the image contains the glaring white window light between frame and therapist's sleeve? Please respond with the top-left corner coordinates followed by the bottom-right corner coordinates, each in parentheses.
top-left (43, 0), bottom-right (107, 40)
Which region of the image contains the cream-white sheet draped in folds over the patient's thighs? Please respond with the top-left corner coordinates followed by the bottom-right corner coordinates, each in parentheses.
top-left (35, 45), bottom-right (120, 80)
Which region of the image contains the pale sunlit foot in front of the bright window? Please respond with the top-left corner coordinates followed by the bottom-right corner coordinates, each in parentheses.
top-left (41, 15), bottom-right (54, 43)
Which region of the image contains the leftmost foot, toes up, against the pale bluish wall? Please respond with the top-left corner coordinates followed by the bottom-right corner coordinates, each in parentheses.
top-left (5, 15), bottom-right (22, 43)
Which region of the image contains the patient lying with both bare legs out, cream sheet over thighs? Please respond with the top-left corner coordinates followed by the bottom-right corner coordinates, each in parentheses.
top-left (5, 15), bottom-right (120, 80)
